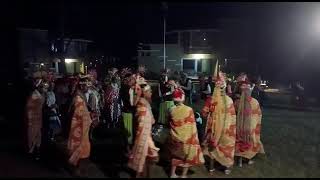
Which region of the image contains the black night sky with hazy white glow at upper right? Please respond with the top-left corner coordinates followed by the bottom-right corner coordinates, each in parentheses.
top-left (6, 0), bottom-right (320, 89)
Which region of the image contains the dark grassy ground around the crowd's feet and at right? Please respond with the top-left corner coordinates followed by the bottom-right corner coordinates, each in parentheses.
top-left (0, 94), bottom-right (320, 178)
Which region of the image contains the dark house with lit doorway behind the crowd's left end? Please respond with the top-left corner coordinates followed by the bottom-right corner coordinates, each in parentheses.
top-left (17, 28), bottom-right (93, 74)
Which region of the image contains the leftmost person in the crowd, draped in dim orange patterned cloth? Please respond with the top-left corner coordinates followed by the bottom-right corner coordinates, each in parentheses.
top-left (26, 78), bottom-right (48, 160)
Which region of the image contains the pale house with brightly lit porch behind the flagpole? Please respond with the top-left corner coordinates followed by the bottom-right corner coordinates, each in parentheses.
top-left (138, 29), bottom-right (219, 76)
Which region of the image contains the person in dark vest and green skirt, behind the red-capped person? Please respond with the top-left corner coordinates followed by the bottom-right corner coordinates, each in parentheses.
top-left (158, 70), bottom-right (175, 126)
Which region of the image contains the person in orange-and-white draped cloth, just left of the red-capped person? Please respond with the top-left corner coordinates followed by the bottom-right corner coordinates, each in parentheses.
top-left (128, 79), bottom-right (159, 177)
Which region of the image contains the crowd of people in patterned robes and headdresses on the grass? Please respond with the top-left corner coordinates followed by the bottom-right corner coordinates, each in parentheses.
top-left (26, 66), bottom-right (264, 178)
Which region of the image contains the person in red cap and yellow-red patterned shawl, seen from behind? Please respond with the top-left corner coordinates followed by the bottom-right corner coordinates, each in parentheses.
top-left (169, 88), bottom-right (204, 178)
